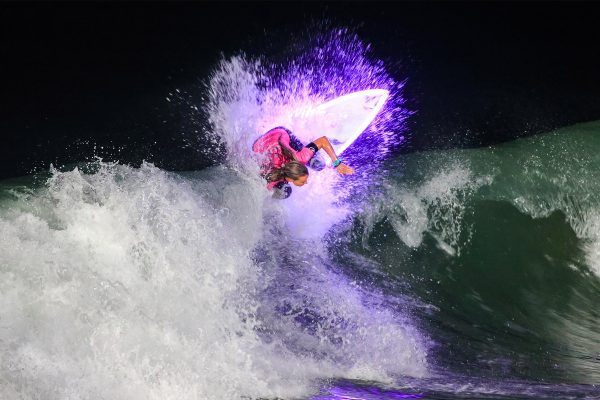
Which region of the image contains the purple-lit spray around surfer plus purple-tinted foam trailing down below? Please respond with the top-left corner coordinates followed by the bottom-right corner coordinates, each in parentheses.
top-left (199, 25), bottom-right (426, 380)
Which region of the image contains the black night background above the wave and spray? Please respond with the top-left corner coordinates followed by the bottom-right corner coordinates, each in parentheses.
top-left (0, 2), bottom-right (600, 178)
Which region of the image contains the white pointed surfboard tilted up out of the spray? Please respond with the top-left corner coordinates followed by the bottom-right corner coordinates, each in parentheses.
top-left (313, 89), bottom-right (389, 156)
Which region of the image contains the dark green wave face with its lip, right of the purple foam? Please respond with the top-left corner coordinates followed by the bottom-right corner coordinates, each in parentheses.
top-left (348, 122), bottom-right (600, 390)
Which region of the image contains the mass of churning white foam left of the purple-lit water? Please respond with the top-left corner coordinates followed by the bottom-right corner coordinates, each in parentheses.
top-left (0, 166), bottom-right (302, 399)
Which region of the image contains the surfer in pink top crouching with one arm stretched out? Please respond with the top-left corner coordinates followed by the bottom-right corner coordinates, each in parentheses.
top-left (252, 126), bottom-right (354, 199)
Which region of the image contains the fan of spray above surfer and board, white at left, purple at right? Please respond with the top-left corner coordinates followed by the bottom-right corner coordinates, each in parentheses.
top-left (205, 29), bottom-right (411, 170)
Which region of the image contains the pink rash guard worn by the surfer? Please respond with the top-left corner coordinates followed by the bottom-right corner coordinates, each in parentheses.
top-left (252, 127), bottom-right (316, 190)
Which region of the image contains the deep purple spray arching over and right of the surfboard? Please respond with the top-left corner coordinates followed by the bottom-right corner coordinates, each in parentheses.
top-left (262, 29), bottom-right (412, 164)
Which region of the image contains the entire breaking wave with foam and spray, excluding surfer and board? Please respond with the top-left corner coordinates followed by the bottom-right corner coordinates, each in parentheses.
top-left (0, 26), bottom-right (600, 400)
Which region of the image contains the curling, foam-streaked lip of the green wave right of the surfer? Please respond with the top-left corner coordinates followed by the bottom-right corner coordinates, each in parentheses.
top-left (362, 122), bottom-right (600, 279)
